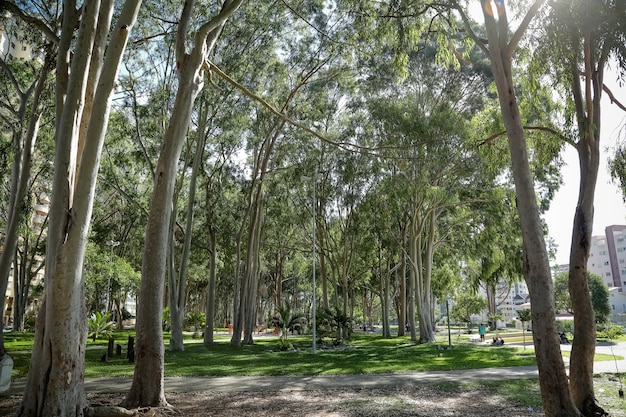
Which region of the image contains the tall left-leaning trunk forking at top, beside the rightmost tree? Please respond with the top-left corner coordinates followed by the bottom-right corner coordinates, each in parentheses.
top-left (483, 0), bottom-right (580, 417)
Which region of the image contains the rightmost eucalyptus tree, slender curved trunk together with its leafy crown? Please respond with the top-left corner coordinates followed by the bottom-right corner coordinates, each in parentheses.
top-left (540, 1), bottom-right (626, 416)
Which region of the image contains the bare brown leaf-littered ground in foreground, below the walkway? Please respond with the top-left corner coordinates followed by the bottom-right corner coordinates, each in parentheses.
top-left (0, 386), bottom-right (543, 417)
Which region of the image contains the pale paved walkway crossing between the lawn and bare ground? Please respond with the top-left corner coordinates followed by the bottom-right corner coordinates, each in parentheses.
top-left (3, 342), bottom-right (626, 395)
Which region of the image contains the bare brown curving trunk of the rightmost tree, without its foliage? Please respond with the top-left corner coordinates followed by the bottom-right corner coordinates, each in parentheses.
top-left (569, 27), bottom-right (606, 416)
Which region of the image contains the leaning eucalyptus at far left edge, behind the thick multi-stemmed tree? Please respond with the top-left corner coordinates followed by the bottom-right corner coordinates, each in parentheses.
top-left (0, 4), bottom-right (58, 357)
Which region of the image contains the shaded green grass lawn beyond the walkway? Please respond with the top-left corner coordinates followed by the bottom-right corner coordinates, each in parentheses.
top-left (5, 331), bottom-right (624, 378)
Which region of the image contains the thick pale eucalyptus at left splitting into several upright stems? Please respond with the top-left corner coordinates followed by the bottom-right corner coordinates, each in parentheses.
top-left (3, 1), bottom-right (141, 416)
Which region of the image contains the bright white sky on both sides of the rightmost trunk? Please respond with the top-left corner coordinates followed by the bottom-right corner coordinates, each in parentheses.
top-left (544, 72), bottom-right (626, 264)
